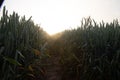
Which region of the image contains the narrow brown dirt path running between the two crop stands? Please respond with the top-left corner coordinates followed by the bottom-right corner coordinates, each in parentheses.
top-left (45, 38), bottom-right (62, 80)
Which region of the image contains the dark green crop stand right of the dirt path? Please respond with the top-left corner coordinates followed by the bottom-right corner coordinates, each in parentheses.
top-left (56, 18), bottom-right (120, 80)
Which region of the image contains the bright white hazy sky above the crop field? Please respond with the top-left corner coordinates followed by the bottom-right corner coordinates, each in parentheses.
top-left (0, 0), bottom-right (120, 34)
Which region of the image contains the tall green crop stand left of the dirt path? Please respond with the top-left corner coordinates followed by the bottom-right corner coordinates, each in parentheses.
top-left (0, 7), bottom-right (47, 80)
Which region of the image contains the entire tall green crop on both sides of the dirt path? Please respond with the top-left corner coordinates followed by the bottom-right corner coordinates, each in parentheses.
top-left (0, 7), bottom-right (120, 80)
